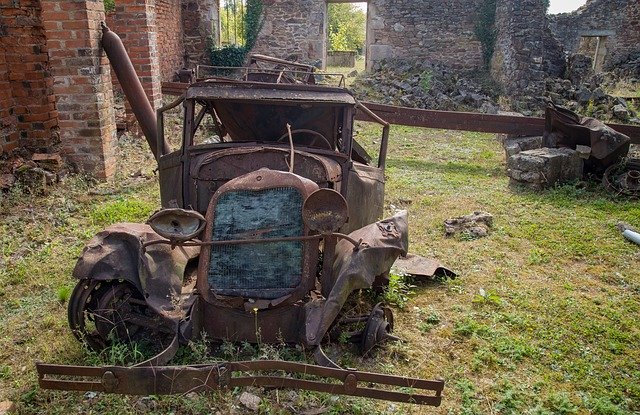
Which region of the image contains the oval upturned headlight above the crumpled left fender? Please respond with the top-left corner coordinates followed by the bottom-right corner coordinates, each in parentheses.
top-left (147, 208), bottom-right (206, 242)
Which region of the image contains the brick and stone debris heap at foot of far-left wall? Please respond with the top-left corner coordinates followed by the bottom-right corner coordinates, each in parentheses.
top-left (0, 153), bottom-right (68, 193)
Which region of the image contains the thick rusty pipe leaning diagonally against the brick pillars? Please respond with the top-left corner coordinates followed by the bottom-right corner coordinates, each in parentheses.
top-left (101, 22), bottom-right (170, 161)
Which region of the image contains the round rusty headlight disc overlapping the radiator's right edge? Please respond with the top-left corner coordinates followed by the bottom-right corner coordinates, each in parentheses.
top-left (302, 189), bottom-right (349, 233)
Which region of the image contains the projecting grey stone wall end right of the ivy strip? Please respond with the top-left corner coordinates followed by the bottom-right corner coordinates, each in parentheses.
top-left (491, 0), bottom-right (545, 96)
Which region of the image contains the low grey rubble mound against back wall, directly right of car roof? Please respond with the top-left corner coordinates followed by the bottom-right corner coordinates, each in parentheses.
top-left (352, 60), bottom-right (498, 114)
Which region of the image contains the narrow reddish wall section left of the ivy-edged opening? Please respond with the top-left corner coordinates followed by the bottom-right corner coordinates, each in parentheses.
top-left (182, 0), bottom-right (220, 68)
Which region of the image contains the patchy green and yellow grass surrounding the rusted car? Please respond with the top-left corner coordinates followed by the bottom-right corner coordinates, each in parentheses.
top-left (0, 124), bottom-right (640, 415)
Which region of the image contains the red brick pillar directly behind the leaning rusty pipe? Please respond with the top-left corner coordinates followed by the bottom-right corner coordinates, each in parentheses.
top-left (109, 0), bottom-right (162, 115)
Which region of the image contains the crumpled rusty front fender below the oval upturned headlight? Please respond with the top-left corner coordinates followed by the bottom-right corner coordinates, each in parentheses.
top-left (73, 223), bottom-right (200, 315)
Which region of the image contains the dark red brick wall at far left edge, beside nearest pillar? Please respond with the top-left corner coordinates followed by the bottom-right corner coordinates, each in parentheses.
top-left (0, 0), bottom-right (58, 153)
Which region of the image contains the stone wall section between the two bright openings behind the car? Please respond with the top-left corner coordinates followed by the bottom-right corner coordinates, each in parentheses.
top-left (253, 0), bottom-right (327, 64)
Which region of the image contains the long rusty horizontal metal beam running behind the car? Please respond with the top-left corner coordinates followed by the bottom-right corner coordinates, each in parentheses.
top-left (162, 82), bottom-right (640, 144)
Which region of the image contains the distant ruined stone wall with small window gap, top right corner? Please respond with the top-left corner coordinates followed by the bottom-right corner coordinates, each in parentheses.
top-left (549, 0), bottom-right (640, 66)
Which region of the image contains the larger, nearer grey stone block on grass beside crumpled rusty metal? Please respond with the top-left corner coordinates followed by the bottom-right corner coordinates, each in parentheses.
top-left (507, 147), bottom-right (584, 189)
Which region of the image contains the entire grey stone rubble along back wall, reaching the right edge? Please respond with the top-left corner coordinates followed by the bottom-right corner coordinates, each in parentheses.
top-left (352, 54), bottom-right (640, 124)
